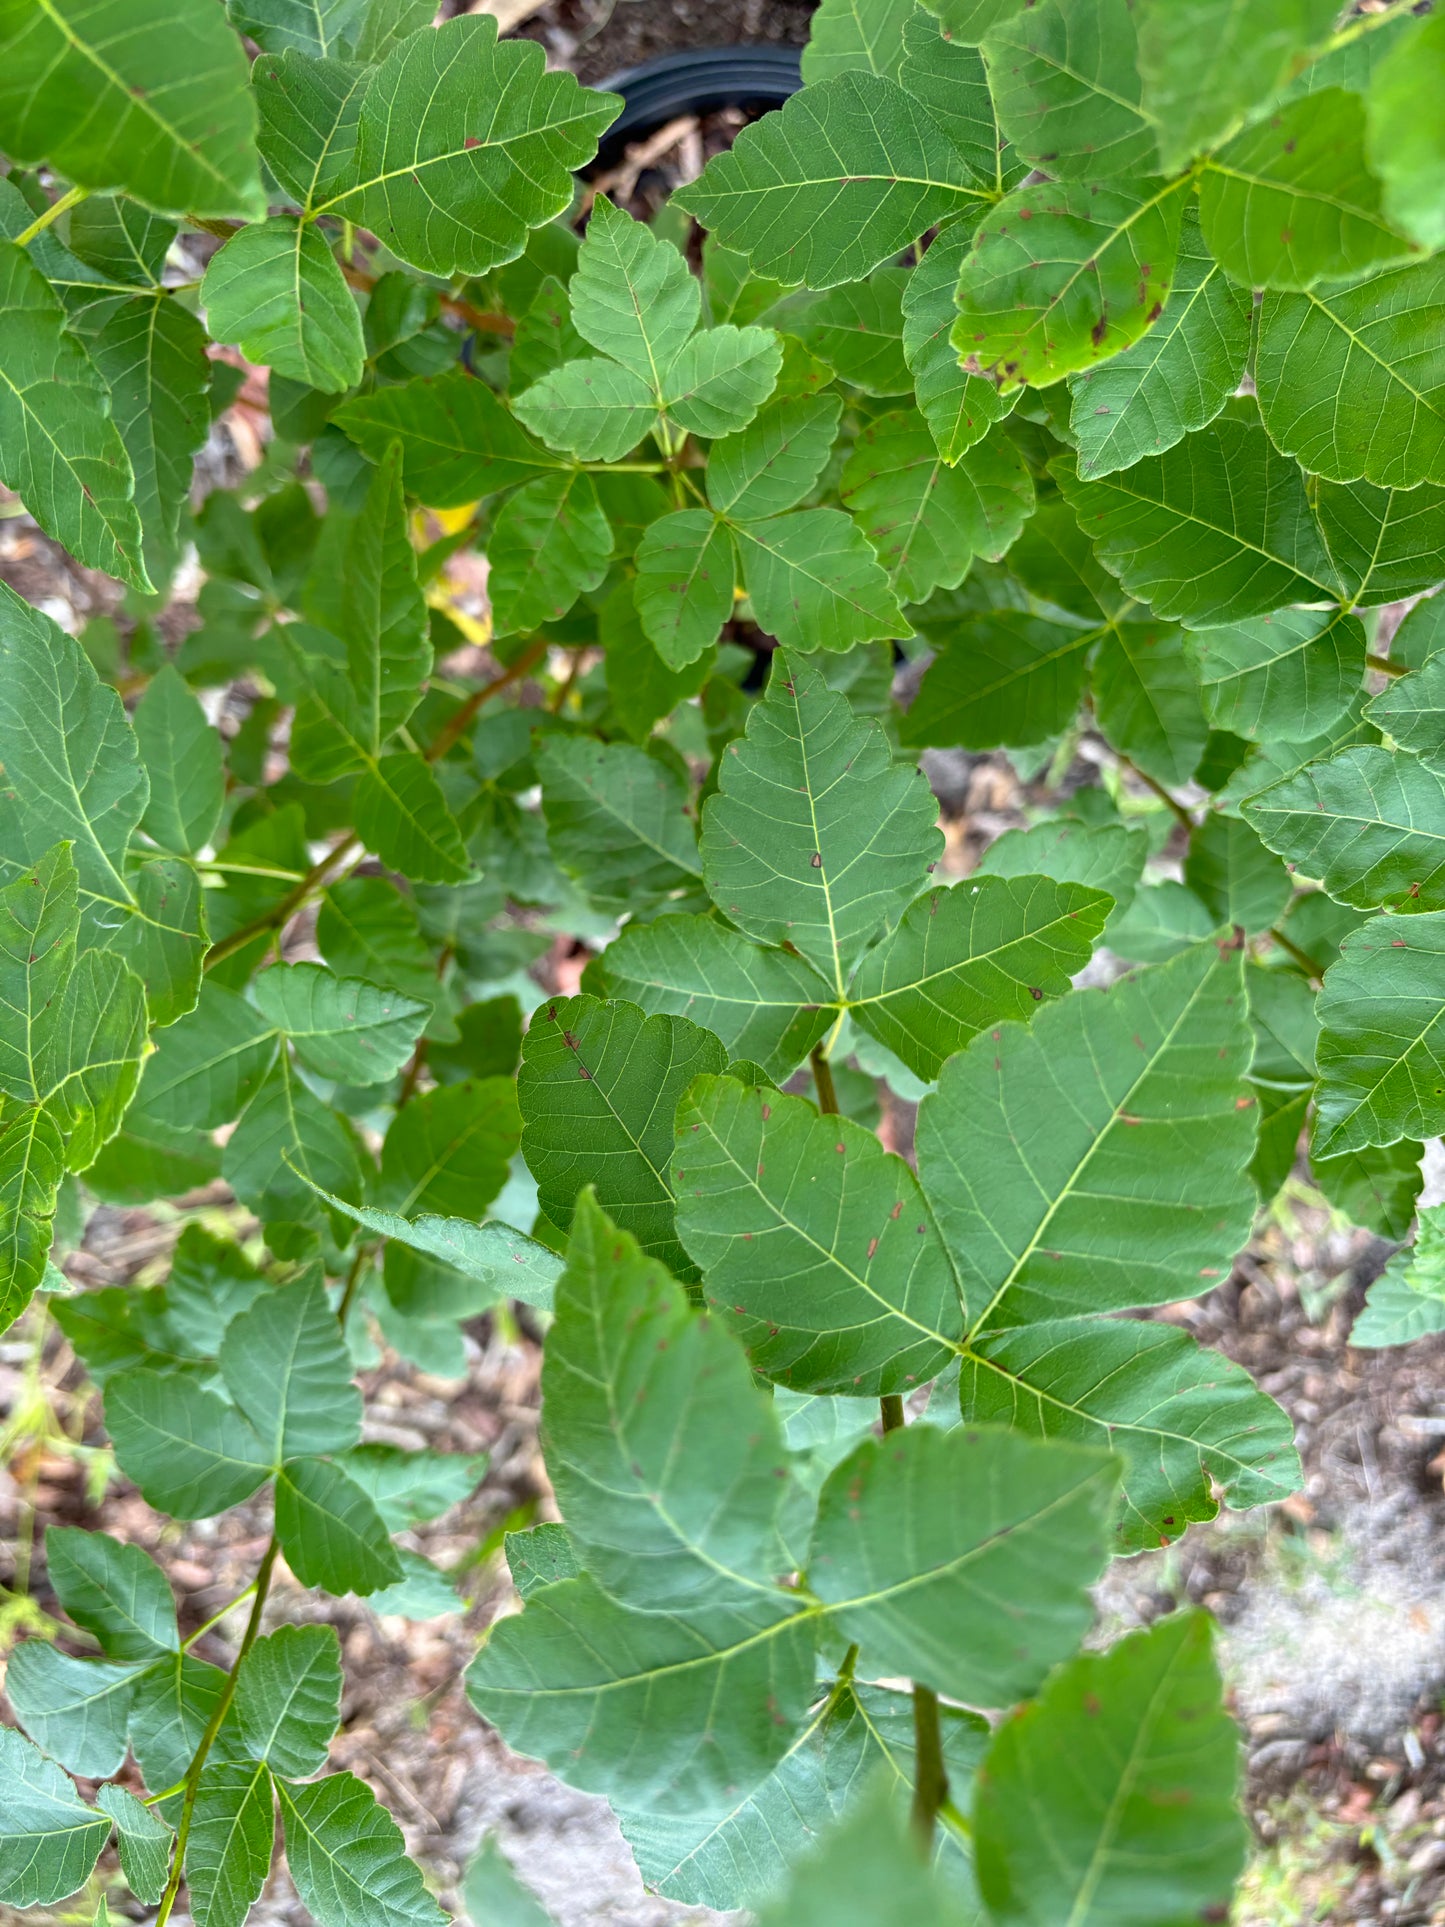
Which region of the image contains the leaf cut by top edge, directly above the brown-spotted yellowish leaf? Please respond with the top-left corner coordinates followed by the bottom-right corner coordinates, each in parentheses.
top-left (983, 0), bottom-right (1156, 181)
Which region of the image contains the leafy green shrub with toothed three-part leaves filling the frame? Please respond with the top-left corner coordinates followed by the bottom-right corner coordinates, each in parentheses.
top-left (0, 0), bottom-right (1445, 1927)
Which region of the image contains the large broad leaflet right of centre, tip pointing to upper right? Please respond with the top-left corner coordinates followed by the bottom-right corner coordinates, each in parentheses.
top-left (917, 944), bottom-right (1254, 1335)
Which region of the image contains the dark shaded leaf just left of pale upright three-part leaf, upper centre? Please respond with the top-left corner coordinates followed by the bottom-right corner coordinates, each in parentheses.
top-left (333, 368), bottom-right (559, 509)
